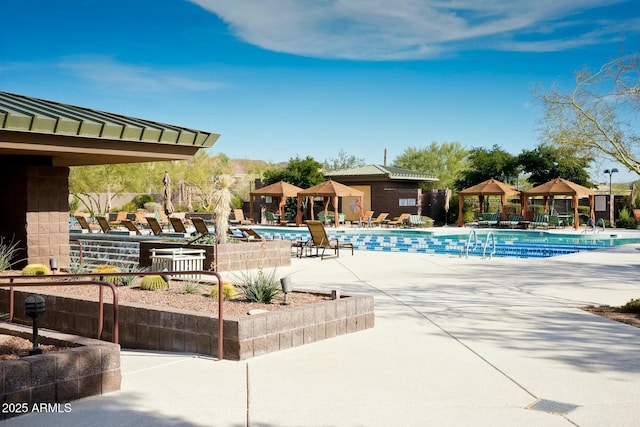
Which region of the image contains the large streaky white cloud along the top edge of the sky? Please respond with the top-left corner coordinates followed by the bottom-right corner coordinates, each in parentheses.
top-left (191, 0), bottom-right (638, 60)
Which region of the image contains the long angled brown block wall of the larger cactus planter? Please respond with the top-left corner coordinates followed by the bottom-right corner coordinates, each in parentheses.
top-left (0, 289), bottom-right (375, 360)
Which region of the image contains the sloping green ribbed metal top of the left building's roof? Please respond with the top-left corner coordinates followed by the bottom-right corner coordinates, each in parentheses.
top-left (0, 92), bottom-right (219, 147)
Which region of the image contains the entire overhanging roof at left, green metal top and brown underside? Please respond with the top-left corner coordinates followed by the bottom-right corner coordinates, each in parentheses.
top-left (0, 92), bottom-right (220, 166)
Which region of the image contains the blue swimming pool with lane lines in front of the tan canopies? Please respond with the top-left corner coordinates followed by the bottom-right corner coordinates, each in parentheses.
top-left (251, 227), bottom-right (640, 258)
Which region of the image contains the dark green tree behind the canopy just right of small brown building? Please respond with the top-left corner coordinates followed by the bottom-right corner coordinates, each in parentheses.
top-left (454, 145), bottom-right (519, 190)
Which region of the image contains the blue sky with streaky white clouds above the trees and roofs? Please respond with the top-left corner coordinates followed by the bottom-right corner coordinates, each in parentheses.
top-left (0, 0), bottom-right (640, 182)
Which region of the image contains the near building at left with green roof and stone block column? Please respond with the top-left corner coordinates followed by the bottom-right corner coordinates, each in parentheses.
top-left (0, 92), bottom-right (220, 267)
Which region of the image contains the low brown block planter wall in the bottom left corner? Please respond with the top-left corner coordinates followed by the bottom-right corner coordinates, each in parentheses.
top-left (0, 323), bottom-right (121, 419)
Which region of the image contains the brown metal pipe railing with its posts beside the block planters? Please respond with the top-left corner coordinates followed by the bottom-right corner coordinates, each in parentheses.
top-left (0, 270), bottom-right (224, 360)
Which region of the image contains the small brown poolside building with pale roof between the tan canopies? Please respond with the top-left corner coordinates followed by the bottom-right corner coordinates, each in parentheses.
top-left (324, 165), bottom-right (438, 218)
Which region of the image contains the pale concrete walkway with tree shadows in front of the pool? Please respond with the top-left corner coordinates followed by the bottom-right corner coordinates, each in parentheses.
top-left (2, 245), bottom-right (640, 427)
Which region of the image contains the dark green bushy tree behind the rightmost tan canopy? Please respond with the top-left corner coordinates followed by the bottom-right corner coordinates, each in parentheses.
top-left (518, 144), bottom-right (593, 188)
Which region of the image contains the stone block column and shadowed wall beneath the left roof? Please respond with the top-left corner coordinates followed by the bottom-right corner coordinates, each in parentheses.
top-left (0, 158), bottom-right (70, 268)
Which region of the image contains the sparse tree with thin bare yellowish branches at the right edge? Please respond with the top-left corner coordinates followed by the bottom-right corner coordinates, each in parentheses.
top-left (538, 53), bottom-right (640, 175)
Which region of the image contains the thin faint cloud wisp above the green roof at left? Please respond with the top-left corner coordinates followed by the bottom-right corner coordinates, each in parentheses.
top-left (59, 56), bottom-right (224, 92)
